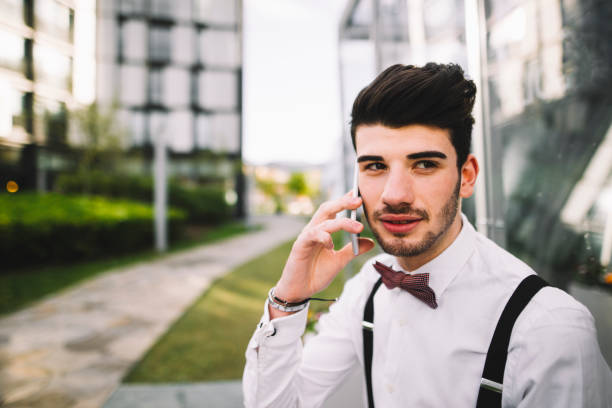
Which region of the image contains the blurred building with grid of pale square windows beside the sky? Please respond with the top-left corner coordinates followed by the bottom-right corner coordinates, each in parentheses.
top-left (96, 0), bottom-right (243, 215)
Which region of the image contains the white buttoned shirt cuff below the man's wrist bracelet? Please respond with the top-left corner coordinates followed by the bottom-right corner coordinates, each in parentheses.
top-left (249, 300), bottom-right (308, 348)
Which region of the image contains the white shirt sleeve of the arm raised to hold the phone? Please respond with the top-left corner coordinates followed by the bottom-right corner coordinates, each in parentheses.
top-left (242, 281), bottom-right (366, 408)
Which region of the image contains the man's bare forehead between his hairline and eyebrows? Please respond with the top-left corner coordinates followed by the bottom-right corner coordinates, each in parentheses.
top-left (355, 125), bottom-right (456, 158)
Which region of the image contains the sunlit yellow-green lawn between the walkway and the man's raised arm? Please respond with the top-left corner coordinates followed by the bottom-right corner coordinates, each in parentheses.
top-left (124, 231), bottom-right (372, 383)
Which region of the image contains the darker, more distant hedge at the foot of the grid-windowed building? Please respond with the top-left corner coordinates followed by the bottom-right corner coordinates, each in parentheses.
top-left (55, 172), bottom-right (232, 224)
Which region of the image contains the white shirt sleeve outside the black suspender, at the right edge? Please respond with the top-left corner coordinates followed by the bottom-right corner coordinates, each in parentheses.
top-left (502, 288), bottom-right (612, 408)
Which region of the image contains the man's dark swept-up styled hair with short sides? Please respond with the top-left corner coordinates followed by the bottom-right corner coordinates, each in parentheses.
top-left (351, 62), bottom-right (476, 169)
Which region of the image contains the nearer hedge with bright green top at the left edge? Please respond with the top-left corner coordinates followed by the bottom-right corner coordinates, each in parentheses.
top-left (0, 192), bottom-right (185, 267)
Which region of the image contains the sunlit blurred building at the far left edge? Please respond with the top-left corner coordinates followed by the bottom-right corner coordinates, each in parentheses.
top-left (0, 0), bottom-right (94, 189)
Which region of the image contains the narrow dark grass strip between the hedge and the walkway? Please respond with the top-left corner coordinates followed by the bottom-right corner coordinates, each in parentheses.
top-left (0, 222), bottom-right (255, 315)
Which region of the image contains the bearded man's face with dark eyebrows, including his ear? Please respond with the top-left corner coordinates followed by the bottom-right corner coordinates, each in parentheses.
top-left (356, 125), bottom-right (477, 267)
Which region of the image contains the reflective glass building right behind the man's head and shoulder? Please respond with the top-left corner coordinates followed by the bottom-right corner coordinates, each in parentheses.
top-left (339, 0), bottom-right (612, 362)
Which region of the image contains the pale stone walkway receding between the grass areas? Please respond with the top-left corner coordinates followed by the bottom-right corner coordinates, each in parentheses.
top-left (0, 217), bottom-right (304, 408)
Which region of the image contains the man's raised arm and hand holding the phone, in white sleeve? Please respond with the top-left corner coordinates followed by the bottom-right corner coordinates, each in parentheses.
top-left (243, 193), bottom-right (374, 408)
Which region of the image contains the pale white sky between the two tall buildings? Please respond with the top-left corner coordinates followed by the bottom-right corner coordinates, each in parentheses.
top-left (243, 0), bottom-right (346, 164)
